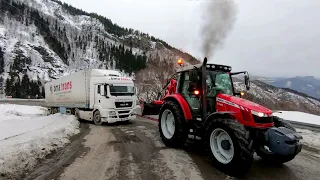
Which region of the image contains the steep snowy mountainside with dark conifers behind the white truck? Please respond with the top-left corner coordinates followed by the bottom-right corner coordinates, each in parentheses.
top-left (0, 0), bottom-right (197, 93)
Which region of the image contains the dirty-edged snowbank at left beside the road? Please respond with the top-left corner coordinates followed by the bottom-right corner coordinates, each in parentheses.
top-left (0, 104), bottom-right (80, 176)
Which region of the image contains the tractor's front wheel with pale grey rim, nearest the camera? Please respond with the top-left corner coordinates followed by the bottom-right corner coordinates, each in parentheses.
top-left (205, 119), bottom-right (254, 175)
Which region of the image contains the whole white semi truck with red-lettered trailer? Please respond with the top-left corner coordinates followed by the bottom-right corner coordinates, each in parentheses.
top-left (45, 69), bottom-right (141, 125)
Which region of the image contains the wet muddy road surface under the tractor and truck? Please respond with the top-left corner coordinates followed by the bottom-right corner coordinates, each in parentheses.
top-left (24, 118), bottom-right (320, 180)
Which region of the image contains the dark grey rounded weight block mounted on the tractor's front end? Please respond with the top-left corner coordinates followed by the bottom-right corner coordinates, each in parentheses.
top-left (266, 127), bottom-right (302, 155)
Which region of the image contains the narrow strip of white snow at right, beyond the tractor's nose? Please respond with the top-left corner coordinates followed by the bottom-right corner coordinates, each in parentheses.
top-left (273, 111), bottom-right (320, 126)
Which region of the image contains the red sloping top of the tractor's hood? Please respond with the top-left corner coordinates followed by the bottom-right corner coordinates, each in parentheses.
top-left (217, 94), bottom-right (272, 116)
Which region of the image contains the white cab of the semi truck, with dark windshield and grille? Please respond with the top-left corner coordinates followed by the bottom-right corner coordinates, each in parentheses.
top-left (92, 76), bottom-right (140, 123)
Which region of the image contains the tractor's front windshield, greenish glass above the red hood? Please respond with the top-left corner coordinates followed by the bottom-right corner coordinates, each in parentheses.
top-left (206, 71), bottom-right (233, 97)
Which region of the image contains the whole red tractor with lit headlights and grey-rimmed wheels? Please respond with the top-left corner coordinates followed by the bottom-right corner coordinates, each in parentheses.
top-left (156, 58), bottom-right (302, 174)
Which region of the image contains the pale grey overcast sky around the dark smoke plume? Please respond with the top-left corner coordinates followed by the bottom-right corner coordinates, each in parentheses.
top-left (63, 0), bottom-right (320, 77)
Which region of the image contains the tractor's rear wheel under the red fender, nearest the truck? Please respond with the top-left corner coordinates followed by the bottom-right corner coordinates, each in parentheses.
top-left (158, 101), bottom-right (188, 147)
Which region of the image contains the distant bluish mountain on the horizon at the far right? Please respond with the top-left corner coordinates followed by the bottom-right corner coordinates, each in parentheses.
top-left (257, 76), bottom-right (320, 99)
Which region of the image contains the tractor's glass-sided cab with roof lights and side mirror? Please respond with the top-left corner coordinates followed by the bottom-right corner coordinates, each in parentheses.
top-left (176, 58), bottom-right (250, 119)
